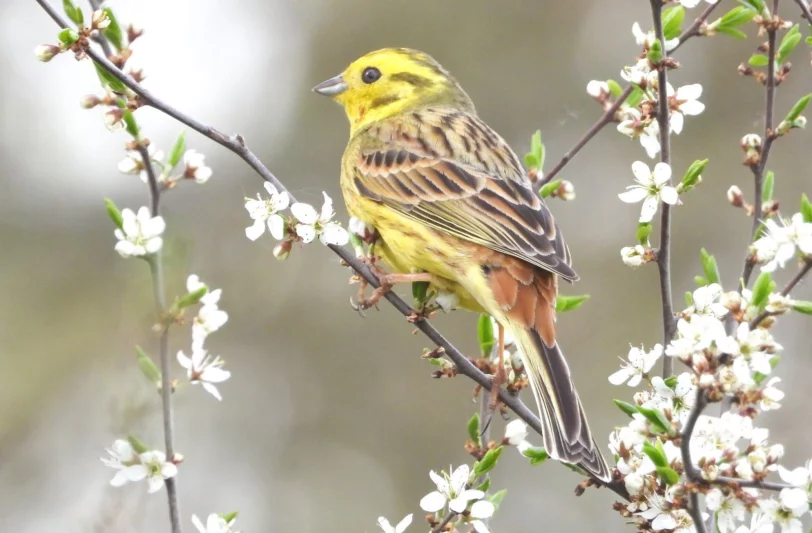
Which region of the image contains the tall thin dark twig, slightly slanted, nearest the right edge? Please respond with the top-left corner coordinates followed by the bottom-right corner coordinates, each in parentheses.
top-left (741, 5), bottom-right (778, 288)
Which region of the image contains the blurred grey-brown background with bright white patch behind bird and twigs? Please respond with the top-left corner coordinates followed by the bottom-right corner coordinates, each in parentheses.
top-left (0, 0), bottom-right (812, 533)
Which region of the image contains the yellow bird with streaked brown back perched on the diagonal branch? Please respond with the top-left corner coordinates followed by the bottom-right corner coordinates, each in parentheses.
top-left (313, 48), bottom-right (611, 481)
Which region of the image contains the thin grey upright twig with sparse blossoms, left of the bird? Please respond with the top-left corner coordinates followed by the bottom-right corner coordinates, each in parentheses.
top-left (137, 143), bottom-right (181, 533)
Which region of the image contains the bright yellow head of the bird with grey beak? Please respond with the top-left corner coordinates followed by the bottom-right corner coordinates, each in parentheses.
top-left (313, 48), bottom-right (474, 134)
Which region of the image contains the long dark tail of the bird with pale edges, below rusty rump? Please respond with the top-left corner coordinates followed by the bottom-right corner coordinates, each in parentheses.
top-left (507, 322), bottom-right (611, 481)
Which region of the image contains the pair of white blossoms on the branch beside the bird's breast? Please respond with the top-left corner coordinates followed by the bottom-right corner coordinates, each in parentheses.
top-left (245, 182), bottom-right (349, 259)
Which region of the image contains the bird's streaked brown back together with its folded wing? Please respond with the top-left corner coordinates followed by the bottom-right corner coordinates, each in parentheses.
top-left (352, 113), bottom-right (578, 281)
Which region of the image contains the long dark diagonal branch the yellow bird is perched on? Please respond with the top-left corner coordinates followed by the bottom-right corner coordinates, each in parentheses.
top-left (36, 0), bottom-right (629, 500)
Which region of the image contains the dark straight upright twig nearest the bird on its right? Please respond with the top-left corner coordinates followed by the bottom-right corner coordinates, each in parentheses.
top-left (651, 0), bottom-right (677, 378)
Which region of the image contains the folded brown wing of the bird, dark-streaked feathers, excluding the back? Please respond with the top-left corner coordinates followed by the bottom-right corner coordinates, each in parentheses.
top-left (353, 142), bottom-right (578, 281)
